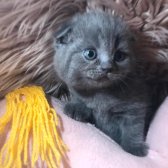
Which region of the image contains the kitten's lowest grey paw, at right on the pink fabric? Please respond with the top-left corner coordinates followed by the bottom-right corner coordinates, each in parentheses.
top-left (123, 142), bottom-right (148, 157)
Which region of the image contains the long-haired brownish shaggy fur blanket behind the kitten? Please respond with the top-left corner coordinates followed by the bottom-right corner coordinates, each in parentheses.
top-left (0, 0), bottom-right (168, 98)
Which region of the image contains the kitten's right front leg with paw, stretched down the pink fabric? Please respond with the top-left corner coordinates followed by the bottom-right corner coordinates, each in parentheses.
top-left (96, 109), bottom-right (148, 156)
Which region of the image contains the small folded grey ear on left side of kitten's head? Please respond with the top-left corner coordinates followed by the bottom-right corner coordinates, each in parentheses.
top-left (54, 22), bottom-right (72, 44)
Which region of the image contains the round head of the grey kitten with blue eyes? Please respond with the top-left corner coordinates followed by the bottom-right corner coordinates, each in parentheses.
top-left (54, 12), bottom-right (135, 89)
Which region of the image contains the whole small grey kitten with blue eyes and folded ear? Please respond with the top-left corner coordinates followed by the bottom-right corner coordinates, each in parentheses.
top-left (54, 11), bottom-right (152, 156)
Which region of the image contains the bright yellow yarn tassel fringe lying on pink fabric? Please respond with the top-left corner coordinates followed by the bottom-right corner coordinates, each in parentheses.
top-left (0, 86), bottom-right (67, 168)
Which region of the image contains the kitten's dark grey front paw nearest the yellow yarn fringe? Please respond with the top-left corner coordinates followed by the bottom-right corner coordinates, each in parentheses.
top-left (64, 102), bottom-right (93, 123)
